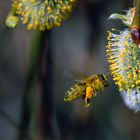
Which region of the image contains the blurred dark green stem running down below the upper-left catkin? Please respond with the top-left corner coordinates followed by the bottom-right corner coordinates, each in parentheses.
top-left (17, 32), bottom-right (42, 140)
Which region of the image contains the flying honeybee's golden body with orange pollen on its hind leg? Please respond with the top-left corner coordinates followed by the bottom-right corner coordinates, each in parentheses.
top-left (64, 73), bottom-right (109, 108)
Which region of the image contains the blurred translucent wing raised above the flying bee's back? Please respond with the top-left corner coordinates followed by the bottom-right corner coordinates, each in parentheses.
top-left (63, 71), bottom-right (88, 83)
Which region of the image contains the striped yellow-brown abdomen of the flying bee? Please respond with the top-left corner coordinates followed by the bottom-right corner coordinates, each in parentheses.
top-left (64, 84), bottom-right (85, 101)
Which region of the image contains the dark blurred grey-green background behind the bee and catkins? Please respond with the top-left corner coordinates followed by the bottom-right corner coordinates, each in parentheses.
top-left (0, 0), bottom-right (140, 140)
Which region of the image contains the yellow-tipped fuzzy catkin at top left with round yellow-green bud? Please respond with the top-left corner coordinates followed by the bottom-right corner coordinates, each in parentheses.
top-left (6, 0), bottom-right (77, 30)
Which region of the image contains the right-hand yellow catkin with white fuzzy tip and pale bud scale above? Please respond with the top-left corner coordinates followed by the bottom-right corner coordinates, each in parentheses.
top-left (106, 8), bottom-right (140, 112)
